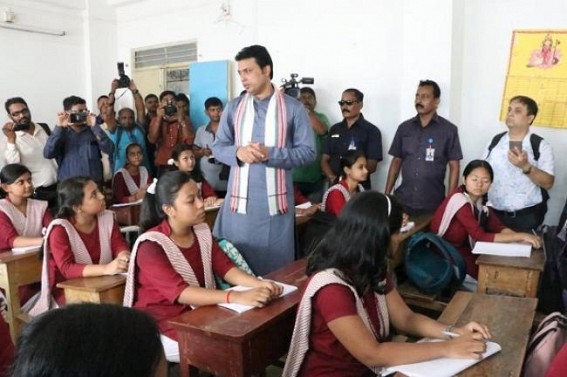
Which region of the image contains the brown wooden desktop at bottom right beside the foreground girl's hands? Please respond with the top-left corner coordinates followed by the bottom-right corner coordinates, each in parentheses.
top-left (439, 291), bottom-right (537, 377)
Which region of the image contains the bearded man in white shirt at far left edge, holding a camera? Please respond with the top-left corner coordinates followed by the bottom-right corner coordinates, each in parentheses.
top-left (0, 97), bottom-right (57, 209)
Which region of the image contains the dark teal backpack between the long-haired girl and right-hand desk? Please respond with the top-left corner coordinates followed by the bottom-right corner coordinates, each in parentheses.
top-left (405, 232), bottom-right (466, 294)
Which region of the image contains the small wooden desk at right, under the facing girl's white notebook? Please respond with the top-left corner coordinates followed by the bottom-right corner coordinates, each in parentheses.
top-left (476, 249), bottom-right (545, 297)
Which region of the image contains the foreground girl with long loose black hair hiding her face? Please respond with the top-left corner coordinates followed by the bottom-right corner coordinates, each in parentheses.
top-left (283, 191), bottom-right (491, 377)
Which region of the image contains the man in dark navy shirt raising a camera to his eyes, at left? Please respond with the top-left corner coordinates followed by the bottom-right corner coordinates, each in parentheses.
top-left (43, 96), bottom-right (114, 185)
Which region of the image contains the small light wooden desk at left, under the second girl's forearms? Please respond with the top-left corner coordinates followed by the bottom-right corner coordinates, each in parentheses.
top-left (57, 275), bottom-right (126, 305)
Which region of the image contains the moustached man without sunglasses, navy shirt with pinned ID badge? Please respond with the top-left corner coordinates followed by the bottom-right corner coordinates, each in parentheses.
top-left (384, 80), bottom-right (463, 215)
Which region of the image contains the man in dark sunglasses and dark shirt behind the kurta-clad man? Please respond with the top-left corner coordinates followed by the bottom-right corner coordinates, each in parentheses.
top-left (321, 89), bottom-right (382, 189)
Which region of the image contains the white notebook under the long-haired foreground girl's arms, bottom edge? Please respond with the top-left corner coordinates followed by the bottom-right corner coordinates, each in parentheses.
top-left (380, 339), bottom-right (502, 377)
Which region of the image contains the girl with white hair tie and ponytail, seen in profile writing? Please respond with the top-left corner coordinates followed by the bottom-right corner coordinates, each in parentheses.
top-left (124, 171), bottom-right (282, 362)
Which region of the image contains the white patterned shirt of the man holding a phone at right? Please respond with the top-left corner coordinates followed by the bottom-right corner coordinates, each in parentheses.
top-left (483, 132), bottom-right (555, 212)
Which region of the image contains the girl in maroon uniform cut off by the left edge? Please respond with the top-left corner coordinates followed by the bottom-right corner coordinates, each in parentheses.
top-left (0, 164), bottom-right (52, 304)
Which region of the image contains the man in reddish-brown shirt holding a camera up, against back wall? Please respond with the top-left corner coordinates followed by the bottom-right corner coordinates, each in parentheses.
top-left (148, 90), bottom-right (194, 177)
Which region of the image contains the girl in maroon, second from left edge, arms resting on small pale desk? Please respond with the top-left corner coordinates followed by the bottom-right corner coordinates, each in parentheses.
top-left (25, 177), bottom-right (130, 316)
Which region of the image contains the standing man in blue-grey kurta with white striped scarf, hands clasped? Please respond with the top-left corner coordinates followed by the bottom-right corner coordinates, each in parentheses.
top-left (213, 45), bottom-right (316, 275)
